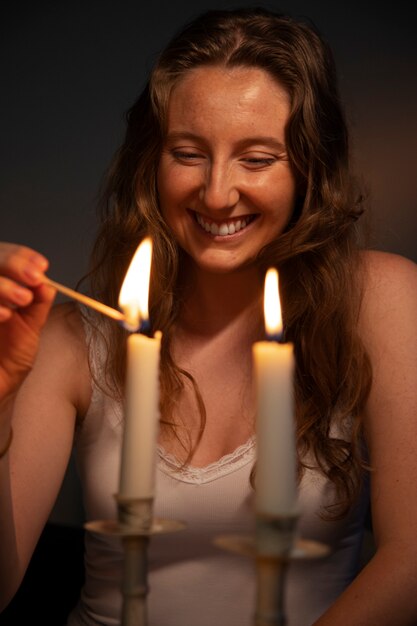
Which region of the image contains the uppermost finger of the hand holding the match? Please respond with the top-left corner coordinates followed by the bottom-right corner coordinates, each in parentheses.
top-left (0, 243), bottom-right (49, 286)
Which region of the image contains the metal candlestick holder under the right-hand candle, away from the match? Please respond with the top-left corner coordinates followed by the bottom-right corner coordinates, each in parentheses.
top-left (215, 515), bottom-right (329, 626)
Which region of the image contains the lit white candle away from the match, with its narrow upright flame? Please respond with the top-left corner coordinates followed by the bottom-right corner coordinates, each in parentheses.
top-left (253, 269), bottom-right (297, 516)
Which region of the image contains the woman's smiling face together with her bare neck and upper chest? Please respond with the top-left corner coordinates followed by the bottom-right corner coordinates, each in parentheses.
top-left (158, 67), bottom-right (297, 466)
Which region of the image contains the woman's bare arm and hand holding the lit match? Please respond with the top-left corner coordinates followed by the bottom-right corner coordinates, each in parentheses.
top-left (0, 244), bottom-right (90, 610)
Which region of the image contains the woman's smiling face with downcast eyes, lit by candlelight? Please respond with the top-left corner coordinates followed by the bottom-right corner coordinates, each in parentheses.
top-left (158, 66), bottom-right (296, 272)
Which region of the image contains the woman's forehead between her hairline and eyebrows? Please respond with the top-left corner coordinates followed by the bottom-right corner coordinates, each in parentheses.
top-left (168, 66), bottom-right (290, 132)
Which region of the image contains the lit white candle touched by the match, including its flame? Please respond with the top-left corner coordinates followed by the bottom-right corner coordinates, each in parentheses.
top-left (119, 238), bottom-right (161, 498)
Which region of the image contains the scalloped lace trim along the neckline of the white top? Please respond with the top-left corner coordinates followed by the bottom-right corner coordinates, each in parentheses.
top-left (158, 436), bottom-right (255, 485)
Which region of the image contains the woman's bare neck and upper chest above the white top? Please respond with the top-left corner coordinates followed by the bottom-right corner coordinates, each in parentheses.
top-left (161, 264), bottom-right (262, 467)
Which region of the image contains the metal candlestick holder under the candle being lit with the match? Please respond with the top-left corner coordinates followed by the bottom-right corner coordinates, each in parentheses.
top-left (84, 494), bottom-right (185, 626)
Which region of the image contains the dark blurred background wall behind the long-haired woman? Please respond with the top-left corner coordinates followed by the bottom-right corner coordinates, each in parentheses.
top-left (0, 0), bottom-right (417, 524)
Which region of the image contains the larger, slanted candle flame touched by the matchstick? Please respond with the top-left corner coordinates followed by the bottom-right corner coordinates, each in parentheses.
top-left (119, 237), bottom-right (152, 330)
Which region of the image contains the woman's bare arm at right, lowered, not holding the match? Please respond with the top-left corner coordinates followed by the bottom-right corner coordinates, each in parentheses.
top-left (315, 253), bottom-right (417, 626)
